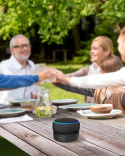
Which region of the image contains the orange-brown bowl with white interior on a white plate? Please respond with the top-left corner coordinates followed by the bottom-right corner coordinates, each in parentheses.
top-left (90, 104), bottom-right (112, 114)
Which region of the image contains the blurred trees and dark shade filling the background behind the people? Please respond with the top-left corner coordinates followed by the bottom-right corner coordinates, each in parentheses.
top-left (0, 0), bottom-right (125, 64)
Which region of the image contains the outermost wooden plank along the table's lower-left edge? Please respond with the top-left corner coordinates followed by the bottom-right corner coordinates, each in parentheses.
top-left (0, 127), bottom-right (45, 156)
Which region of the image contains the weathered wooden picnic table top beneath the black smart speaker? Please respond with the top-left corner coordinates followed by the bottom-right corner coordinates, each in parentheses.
top-left (0, 109), bottom-right (125, 156)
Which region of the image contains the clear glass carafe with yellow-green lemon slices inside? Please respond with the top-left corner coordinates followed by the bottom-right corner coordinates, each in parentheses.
top-left (35, 88), bottom-right (53, 117)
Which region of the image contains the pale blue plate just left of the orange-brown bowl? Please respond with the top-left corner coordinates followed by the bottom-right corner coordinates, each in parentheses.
top-left (65, 103), bottom-right (97, 111)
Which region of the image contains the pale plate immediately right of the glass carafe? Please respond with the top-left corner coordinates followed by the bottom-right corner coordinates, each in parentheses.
top-left (51, 99), bottom-right (80, 105)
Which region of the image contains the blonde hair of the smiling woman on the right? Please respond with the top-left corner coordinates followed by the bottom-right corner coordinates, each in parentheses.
top-left (92, 36), bottom-right (113, 54)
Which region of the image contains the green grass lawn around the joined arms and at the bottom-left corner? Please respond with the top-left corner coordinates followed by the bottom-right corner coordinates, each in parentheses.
top-left (0, 63), bottom-right (87, 156)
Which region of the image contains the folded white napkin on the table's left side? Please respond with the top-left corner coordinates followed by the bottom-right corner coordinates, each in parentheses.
top-left (0, 114), bottom-right (33, 123)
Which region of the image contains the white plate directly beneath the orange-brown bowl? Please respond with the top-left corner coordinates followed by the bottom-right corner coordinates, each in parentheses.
top-left (77, 109), bottom-right (122, 119)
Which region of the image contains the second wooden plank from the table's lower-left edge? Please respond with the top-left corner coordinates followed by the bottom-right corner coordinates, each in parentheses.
top-left (1, 122), bottom-right (78, 156)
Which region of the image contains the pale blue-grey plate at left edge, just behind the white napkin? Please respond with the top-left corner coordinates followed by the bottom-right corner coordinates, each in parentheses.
top-left (0, 108), bottom-right (25, 117)
